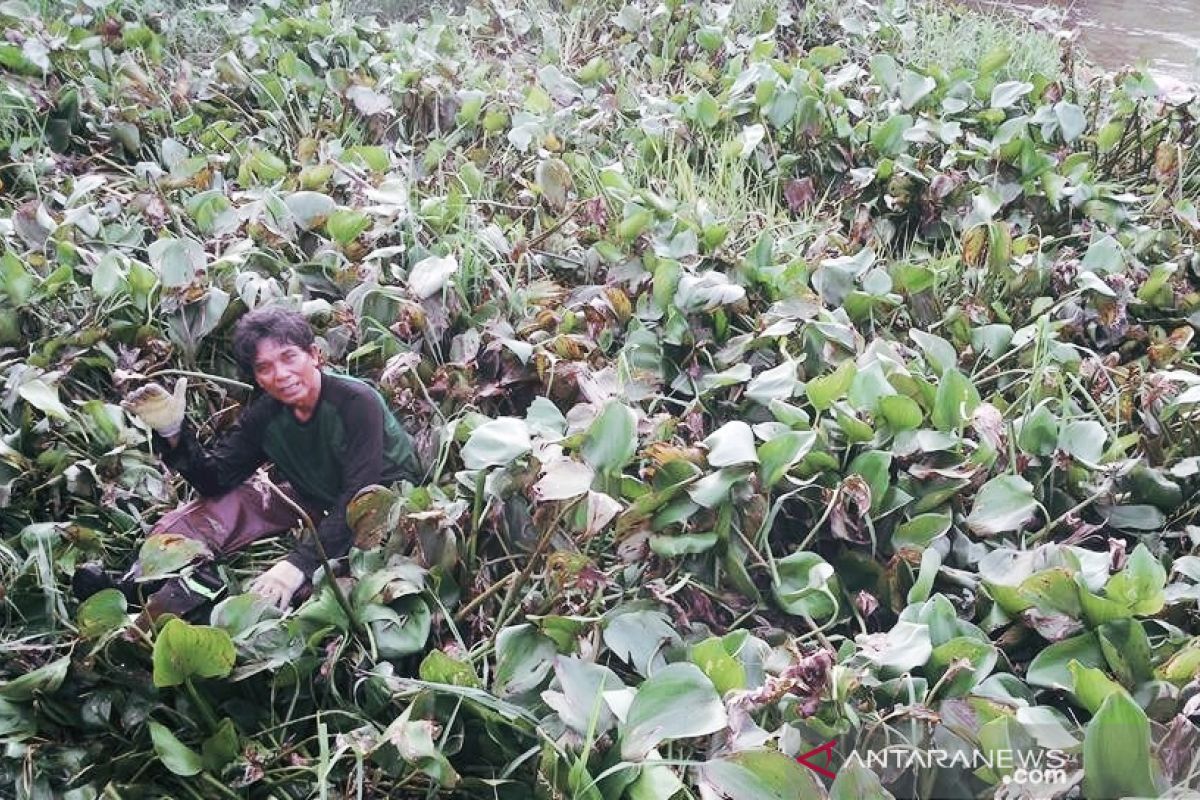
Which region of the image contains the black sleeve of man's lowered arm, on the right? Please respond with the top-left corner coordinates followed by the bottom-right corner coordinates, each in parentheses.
top-left (287, 393), bottom-right (383, 577)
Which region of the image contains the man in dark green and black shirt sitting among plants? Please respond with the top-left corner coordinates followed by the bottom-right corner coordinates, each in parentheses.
top-left (77, 308), bottom-right (420, 619)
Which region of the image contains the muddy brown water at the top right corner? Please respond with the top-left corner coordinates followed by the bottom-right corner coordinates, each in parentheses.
top-left (968, 0), bottom-right (1200, 83)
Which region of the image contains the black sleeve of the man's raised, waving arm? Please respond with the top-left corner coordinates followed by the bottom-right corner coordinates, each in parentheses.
top-left (154, 403), bottom-right (266, 498)
